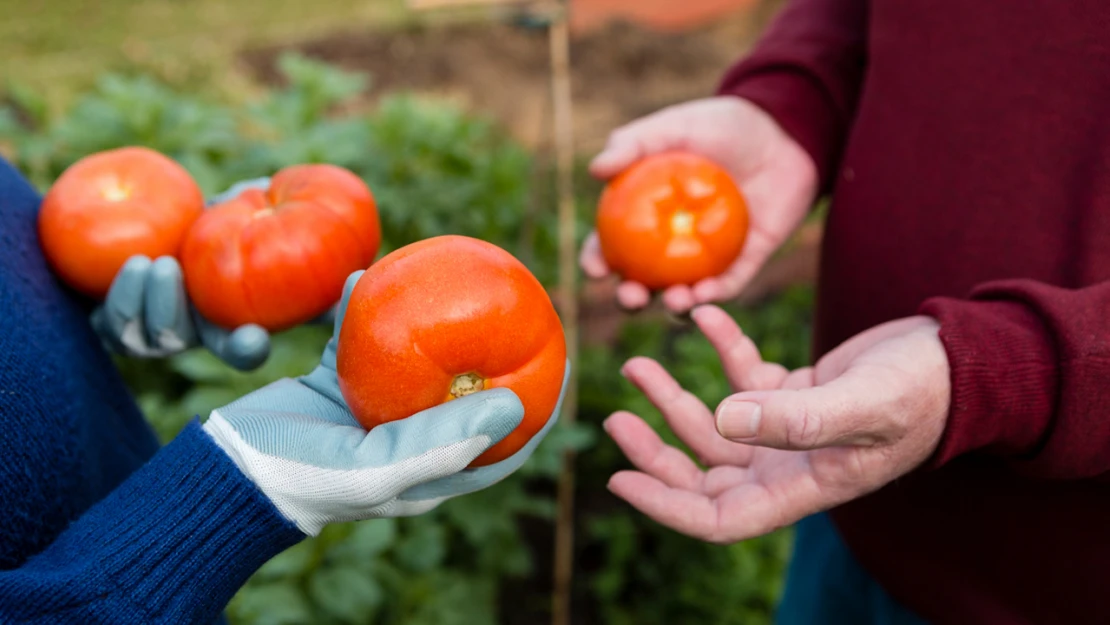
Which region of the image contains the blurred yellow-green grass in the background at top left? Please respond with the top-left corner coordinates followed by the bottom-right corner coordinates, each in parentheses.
top-left (0, 0), bottom-right (417, 108)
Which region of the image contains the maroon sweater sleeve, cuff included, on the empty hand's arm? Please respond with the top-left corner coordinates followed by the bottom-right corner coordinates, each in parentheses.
top-left (920, 280), bottom-right (1110, 480)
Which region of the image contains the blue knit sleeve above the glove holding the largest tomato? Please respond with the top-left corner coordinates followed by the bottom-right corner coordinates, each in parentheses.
top-left (0, 421), bottom-right (305, 625)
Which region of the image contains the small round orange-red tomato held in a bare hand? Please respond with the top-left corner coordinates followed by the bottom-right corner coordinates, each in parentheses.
top-left (597, 152), bottom-right (748, 290)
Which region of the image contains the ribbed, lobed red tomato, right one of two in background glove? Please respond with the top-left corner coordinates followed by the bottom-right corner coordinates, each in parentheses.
top-left (181, 164), bottom-right (382, 332)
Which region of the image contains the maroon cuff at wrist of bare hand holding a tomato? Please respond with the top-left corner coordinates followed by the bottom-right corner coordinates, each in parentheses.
top-left (717, 63), bottom-right (845, 193)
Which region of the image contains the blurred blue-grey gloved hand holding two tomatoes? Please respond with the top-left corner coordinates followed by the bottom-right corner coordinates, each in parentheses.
top-left (91, 178), bottom-right (277, 371)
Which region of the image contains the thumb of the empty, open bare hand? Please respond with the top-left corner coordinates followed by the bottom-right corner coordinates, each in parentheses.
top-left (716, 376), bottom-right (881, 451)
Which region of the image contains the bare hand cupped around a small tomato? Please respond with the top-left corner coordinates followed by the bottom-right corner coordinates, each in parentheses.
top-left (579, 97), bottom-right (818, 313)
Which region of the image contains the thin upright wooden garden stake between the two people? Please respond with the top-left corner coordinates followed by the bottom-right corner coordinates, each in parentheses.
top-left (407, 0), bottom-right (578, 625)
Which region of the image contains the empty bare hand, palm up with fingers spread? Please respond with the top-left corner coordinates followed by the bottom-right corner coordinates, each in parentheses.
top-left (605, 306), bottom-right (951, 543)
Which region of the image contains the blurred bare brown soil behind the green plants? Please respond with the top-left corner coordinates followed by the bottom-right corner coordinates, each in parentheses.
top-left (243, 0), bottom-right (778, 154)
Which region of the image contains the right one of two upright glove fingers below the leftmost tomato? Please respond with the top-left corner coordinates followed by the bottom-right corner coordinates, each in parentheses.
top-left (143, 256), bottom-right (196, 353)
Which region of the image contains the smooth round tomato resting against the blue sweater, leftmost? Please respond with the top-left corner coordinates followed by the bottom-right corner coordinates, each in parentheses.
top-left (39, 147), bottom-right (204, 300)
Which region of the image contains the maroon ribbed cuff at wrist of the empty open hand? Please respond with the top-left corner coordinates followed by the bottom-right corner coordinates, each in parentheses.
top-left (919, 298), bottom-right (1058, 468)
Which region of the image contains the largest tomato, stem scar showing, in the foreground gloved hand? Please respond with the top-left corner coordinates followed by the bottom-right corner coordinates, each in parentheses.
top-left (336, 235), bottom-right (566, 466)
